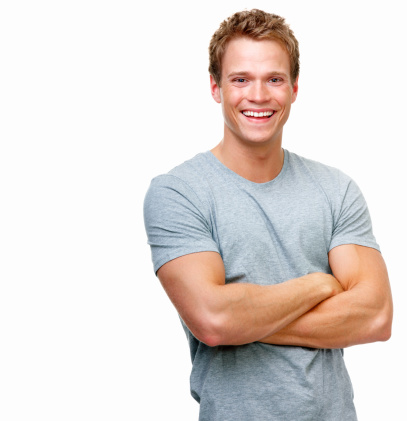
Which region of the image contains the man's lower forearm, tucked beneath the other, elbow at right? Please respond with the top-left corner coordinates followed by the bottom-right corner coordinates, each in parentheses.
top-left (261, 278), bottom-right (392, 348)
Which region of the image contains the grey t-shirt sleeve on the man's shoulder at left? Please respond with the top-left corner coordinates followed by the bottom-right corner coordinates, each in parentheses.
top-left (144, 175), bottom-right (219, 273)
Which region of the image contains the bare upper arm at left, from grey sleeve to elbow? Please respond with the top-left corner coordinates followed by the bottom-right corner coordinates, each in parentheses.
top-left (157, 252), bottom-right (225, 339)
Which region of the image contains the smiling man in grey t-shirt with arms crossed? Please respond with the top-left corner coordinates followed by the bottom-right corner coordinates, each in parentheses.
top-left (145, 10), bottom-right (392, 421)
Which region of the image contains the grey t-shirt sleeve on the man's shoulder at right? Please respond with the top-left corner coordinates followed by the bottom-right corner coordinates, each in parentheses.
top-left (329, 179), bottom-right (380, 251)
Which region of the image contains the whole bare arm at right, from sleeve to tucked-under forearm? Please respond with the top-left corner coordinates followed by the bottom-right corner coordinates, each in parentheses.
top-left (261, 244), bottom-right (393, 348)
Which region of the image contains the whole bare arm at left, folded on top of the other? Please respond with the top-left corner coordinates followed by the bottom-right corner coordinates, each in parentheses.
top-left (157, 252), bottom-right (343, 346)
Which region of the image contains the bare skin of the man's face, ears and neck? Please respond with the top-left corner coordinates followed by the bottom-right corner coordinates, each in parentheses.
top-left (210, 38), bottom-right (298, 183)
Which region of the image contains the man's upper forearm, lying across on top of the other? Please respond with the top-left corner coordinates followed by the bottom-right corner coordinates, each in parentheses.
top-left (196, 274), bottom-right (340, 345)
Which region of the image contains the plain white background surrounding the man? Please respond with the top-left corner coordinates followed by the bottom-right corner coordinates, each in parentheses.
top-left (0, 0), bottom-right (407, 421)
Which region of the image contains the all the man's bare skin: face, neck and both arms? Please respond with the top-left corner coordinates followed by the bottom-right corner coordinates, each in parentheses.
top-left (157, 38), bottom-right (392, 348)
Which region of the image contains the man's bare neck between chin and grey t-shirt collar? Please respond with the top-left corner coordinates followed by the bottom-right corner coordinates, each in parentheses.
top-left (211, 139), bottom-right (284, 183)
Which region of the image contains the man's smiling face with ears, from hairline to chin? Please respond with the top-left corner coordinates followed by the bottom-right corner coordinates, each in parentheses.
top-left (211, 38), bottom-right (298, 145)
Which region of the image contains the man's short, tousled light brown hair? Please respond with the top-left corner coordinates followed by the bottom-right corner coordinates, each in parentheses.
top-left (209, 9), bottom-right (300, 86)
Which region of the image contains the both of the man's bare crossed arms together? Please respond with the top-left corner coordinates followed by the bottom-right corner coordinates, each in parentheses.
top-left (157, 245), bottom-right (392, 348)
